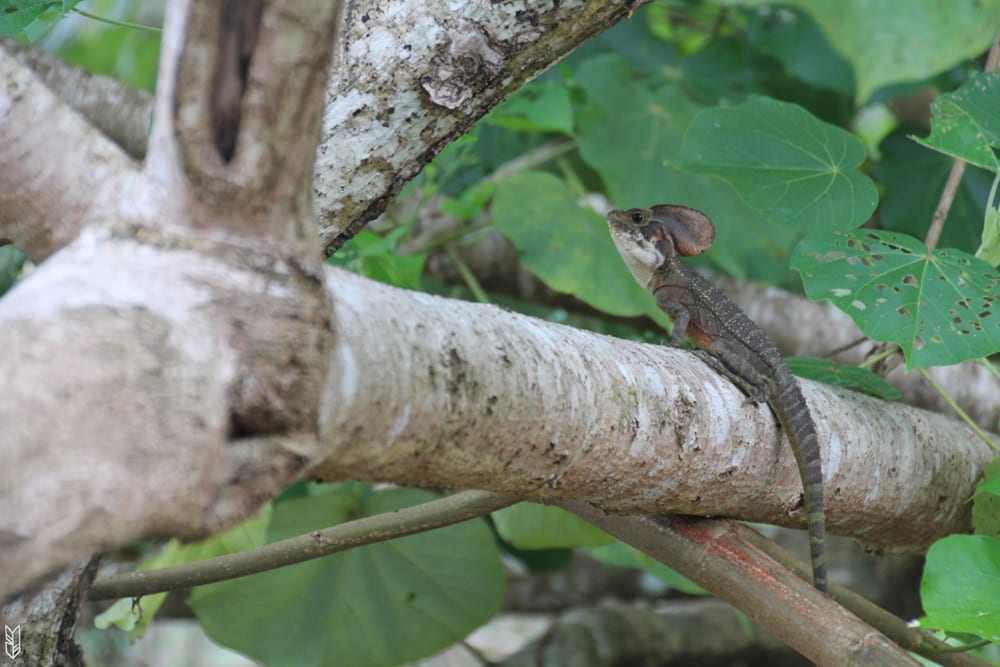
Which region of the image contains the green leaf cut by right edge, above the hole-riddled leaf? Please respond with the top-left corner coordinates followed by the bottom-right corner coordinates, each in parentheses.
top-left (913, 72), bottom-right (1000, 171)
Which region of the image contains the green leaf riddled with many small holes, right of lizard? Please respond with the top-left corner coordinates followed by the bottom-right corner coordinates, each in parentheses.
top-left (792, 230), bottom-right (1000, 370)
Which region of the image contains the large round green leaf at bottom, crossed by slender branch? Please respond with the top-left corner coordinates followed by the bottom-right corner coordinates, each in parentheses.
top-left (190, 489), bottom-right (504, 667)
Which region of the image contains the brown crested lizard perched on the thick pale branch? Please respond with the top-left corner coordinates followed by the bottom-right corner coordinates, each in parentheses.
top-left (608, 205), bottom-right (827, 593)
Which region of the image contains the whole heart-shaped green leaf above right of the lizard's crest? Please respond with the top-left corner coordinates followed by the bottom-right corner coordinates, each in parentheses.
top-left (678, 97), bottom-right (878, 231)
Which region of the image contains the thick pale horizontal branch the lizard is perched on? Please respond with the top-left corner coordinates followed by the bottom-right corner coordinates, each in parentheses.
top-left (316, 271), bottom-right (991, 550)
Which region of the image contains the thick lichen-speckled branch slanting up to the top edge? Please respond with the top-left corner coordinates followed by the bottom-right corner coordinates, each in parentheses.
top-left (314, 0), bottom-right (646, 254)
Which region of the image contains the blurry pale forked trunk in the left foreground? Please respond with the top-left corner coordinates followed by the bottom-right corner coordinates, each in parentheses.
top-left (0, 0), bottom-right (339, 592)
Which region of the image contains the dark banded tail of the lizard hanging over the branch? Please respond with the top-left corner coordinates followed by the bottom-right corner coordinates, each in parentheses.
top-left (768, 367), bottom-right (827, 593)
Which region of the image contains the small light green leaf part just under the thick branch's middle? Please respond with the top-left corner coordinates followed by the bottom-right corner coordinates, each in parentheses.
top-left (491, 502), bottom-right (613, 549)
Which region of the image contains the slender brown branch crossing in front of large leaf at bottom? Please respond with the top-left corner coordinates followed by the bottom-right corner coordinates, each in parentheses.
top-left (89, 491), bottom-right (517, 600)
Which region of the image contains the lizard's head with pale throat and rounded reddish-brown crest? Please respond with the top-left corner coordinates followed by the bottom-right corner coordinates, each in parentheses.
top-left (608, 204), bottom-right (715, 287)
